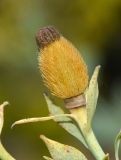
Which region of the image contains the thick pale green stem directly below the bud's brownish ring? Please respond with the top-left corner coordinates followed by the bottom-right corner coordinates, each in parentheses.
top-left (70, 106), bottom-right (105, 160)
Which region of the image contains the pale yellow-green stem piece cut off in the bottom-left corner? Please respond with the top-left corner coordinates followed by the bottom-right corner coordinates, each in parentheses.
top-left (0, 142), bottom-right (15, 160)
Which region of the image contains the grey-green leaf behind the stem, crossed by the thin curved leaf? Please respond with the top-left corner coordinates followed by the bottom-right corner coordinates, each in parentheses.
top-left (44, 95), bottom-right (88, 148)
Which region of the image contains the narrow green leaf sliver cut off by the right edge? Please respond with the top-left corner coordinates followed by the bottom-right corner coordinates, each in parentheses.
top-left (115, 130), bottom-right (121, 160)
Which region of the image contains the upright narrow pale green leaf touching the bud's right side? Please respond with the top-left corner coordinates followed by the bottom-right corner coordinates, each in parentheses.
top-left (85, 66), bottom-right (100, 127)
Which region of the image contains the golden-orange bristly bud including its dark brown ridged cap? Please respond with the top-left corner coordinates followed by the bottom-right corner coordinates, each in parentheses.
top-left (36, 27), bottom-right (88, 99)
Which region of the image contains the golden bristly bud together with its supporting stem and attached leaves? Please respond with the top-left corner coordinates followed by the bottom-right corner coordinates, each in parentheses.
top-left (12, 27), bottom-right (109, 160)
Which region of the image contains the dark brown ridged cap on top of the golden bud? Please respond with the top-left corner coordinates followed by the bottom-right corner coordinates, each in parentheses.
top-left (36, 26), bottom-right (60, 48)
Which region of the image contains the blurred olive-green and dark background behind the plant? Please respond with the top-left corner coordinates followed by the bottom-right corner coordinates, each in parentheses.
top-left (0, 0), bottom-right (121, 160)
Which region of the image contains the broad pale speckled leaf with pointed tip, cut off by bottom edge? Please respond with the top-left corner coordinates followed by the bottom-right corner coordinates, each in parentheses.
top-left (40, 135), bottom-right (87, 160)
